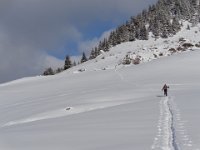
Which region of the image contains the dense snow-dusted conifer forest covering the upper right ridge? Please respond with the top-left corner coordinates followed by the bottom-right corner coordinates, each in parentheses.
top-left (86, 0), bottom-right (200, 60)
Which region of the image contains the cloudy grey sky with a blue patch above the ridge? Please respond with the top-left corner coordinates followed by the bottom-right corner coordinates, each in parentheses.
top-left (0, 0), bottom-right (157, 83)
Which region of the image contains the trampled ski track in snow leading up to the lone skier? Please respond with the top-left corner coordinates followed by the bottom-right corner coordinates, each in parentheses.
top-left (151, 97), bottom-right (199, 150)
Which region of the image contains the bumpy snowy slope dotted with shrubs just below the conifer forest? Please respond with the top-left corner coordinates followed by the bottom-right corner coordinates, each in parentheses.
top-left (61, 21), bottom-right (200, 74)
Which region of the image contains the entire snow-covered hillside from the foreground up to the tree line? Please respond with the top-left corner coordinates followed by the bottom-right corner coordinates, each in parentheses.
top-left (0, 24), bottom-right (200, 150)
